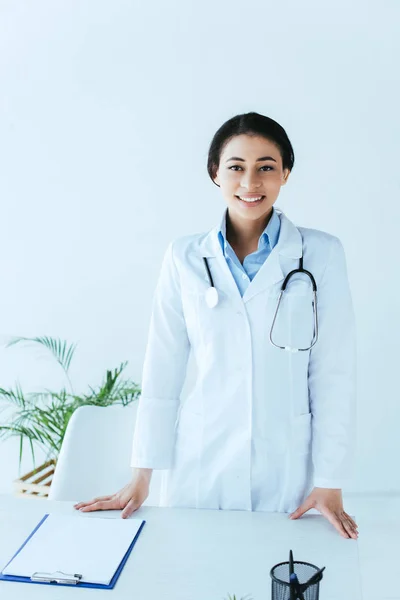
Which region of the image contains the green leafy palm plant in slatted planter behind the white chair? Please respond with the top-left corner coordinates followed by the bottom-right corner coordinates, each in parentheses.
top-left (0, 337), bottom-right (141, 497)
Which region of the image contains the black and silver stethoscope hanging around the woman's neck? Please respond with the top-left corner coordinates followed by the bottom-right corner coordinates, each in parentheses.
top-left (203, 246), bottom-right (318, 352)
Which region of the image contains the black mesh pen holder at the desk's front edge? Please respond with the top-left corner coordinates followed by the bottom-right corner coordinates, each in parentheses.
top-left (270, 560), bottom-right (322, 600)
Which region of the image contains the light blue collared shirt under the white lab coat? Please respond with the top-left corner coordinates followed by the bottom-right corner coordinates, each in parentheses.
top-left (218, 208), bottom-right (281, 296)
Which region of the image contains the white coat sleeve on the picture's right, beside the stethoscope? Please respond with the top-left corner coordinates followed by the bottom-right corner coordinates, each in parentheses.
top-left (308, 236), bottom-right (356, 489)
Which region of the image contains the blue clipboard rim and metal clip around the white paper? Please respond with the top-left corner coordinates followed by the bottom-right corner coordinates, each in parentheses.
top-left (0, 513), bottom-right (146, 590)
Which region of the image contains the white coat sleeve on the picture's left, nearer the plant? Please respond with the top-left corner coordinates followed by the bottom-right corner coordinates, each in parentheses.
top-left (131, 242), bottom-right (190, 469)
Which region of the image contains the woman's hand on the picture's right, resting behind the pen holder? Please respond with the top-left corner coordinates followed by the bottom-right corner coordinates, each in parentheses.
top-left (289, 488), bottom-right (358, 540)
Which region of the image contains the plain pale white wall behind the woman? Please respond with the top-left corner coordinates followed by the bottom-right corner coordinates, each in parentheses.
top-left (0, 0), bottom-right (400, 491)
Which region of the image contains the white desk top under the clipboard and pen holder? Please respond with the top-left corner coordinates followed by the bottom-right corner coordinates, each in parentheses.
top-left (0, 496), bottom-right (400, 600)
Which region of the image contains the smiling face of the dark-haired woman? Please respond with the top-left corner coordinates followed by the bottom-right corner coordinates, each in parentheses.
top-left (214, 134), bottom-right (290, 220)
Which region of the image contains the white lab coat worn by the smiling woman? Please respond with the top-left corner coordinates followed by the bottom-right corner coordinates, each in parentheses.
top-left (131, 212), bottom-right (356, 512)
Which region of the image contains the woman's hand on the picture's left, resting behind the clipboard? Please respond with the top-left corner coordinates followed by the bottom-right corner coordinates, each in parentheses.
top-left (74, 469), bottom-right (153, 519)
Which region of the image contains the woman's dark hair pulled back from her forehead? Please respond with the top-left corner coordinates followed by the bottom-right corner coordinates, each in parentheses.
top-left (207, 112), bottom-right (294, 187)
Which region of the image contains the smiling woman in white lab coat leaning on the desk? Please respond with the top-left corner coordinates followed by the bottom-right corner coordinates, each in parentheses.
top-left (75, 113), bottom-right (358, 539)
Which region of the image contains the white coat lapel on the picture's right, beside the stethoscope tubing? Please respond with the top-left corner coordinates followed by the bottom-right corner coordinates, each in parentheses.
top-left (243, 213), bottom-right (302, 303)
